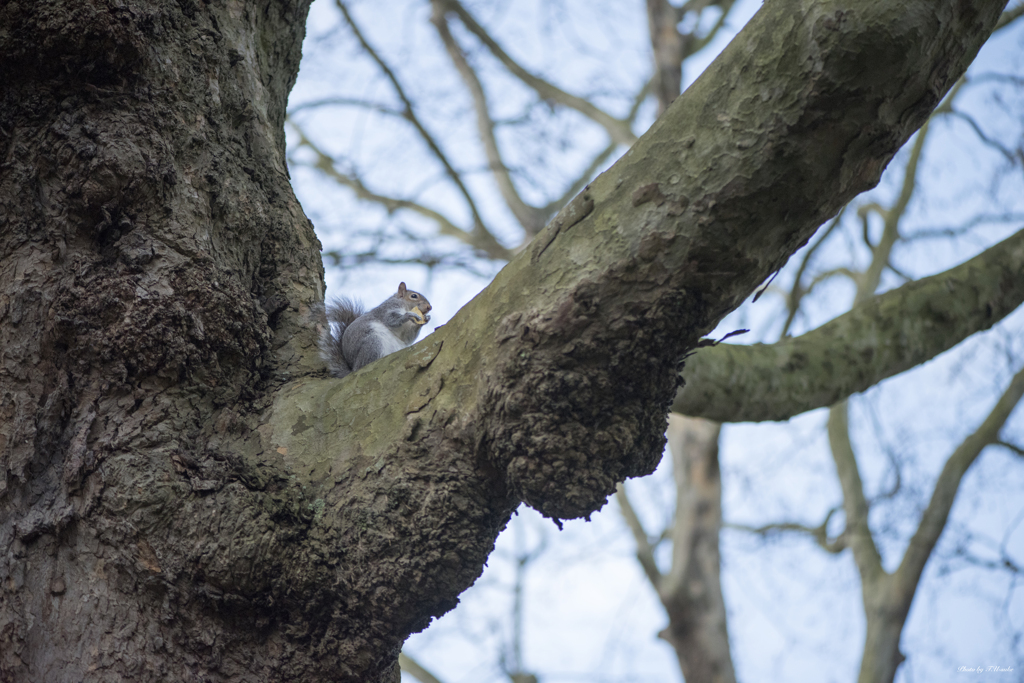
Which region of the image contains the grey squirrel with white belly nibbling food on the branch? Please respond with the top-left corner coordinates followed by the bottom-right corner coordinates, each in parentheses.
top-left (319, 283), bottom-right (431, 377)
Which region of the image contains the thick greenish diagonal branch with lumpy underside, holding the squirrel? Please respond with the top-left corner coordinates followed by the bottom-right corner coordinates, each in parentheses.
top-left (259, 0), bottom-right (1002, 680)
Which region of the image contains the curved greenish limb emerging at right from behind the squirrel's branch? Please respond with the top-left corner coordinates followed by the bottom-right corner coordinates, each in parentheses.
top-left (672, 231), bottom-right (1024, 422)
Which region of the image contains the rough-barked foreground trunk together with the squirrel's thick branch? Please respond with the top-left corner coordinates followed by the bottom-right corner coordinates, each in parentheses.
top-left (0, 0), bottom-right (1004, 682)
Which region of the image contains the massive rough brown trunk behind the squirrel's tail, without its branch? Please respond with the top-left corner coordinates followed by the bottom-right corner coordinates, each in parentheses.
top-left (0, 0), bottom-right (331, 682)
